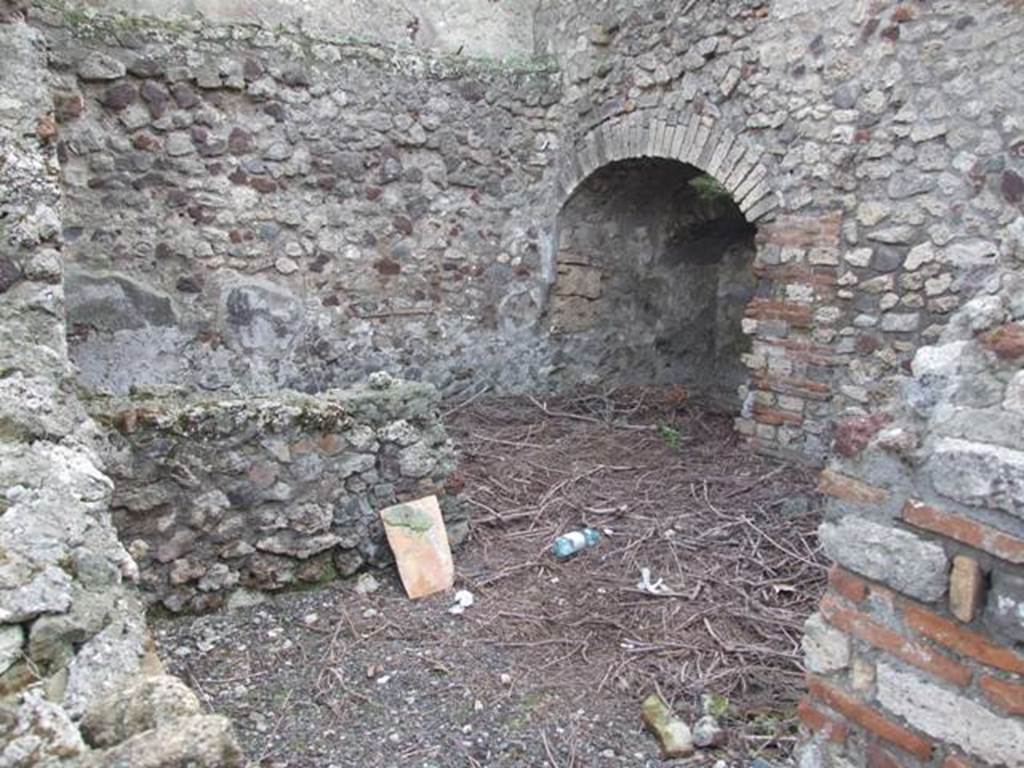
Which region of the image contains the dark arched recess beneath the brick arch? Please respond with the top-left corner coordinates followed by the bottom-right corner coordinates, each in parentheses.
top-left (548, 158), bottom-right (757, 407)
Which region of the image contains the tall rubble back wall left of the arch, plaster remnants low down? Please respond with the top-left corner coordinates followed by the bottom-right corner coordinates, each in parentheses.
top-left (33, 3), bottom-right (558, 403)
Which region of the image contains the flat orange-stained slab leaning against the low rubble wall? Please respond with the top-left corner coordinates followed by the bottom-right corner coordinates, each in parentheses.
top-left (380, 496), bottom-right (455, 600)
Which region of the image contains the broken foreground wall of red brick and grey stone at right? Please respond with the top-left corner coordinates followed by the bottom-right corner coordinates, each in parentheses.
top-left (801, 278), bottom-right (1024, 768)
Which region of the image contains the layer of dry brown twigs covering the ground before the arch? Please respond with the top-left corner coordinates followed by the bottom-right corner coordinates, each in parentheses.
top-left (447, 389), bottom-right (825, 739)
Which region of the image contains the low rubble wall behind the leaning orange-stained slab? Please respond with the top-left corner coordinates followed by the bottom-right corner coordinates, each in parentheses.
top-left (92, 374), bottom-right (468, 612)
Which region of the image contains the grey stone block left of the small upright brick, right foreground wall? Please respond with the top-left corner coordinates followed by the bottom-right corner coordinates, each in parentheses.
top-left (818, 515), bottom-right (949, 602)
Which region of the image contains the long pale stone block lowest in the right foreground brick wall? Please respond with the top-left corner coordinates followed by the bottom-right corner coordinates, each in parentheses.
top-left (878, 664), bottom-right (1024, 768)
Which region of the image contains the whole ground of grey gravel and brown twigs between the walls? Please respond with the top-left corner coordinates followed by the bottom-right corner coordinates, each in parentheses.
top-left (156, 390), bottom-right (824, 768)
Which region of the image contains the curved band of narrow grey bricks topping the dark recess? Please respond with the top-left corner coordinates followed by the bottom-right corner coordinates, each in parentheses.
top-left (558, 106), bottom-right (779, 224)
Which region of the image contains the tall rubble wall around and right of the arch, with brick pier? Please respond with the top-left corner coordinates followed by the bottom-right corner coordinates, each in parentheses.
top-left (537, 0), bottom-right (1024, 461)
